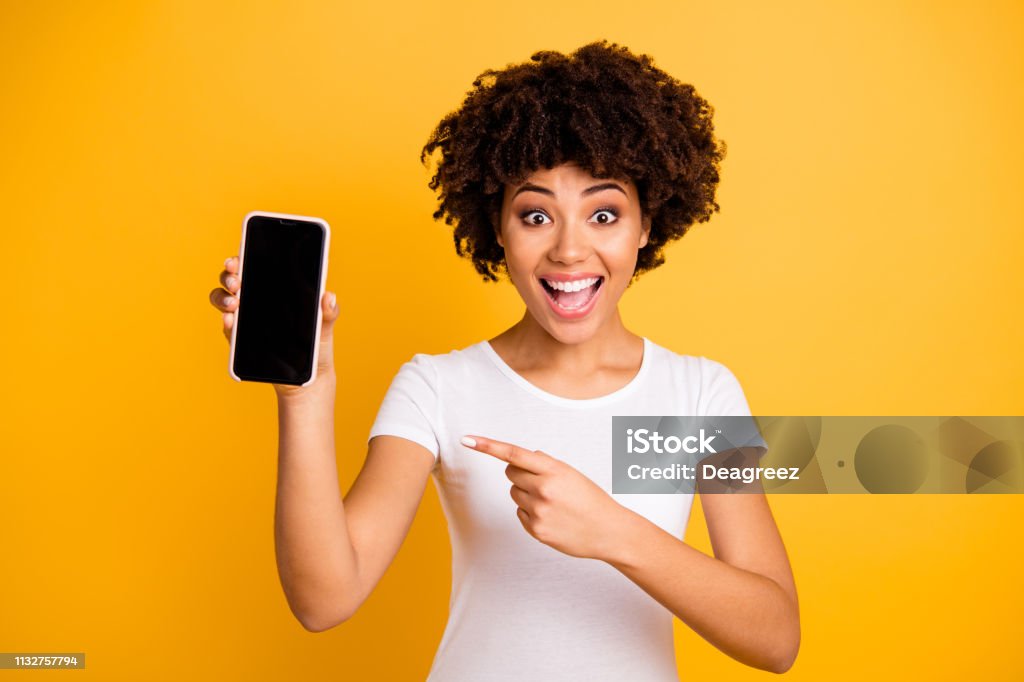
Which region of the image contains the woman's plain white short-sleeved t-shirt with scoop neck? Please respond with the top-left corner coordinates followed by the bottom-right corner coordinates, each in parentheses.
top-left (368, 337), bottom-right (751, 682)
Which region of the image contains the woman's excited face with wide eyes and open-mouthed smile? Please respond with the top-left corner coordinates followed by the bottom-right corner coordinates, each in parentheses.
top-left (498, 163), bottom-right (650, 343)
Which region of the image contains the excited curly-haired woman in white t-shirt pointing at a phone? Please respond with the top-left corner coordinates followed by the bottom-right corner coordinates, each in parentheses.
top-left (211, 41), bottom-right (800, 681)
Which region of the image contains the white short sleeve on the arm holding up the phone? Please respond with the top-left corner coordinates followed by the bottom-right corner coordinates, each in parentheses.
top-left (367, 353), bottom-right (440, 463)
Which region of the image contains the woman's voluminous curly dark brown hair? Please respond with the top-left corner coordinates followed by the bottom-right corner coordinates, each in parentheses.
top-left (420, 40), bottom-right (726, 283)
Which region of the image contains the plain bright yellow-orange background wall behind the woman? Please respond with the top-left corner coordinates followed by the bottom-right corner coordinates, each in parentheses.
top-left (0, 0), bottom-right (1024, 681)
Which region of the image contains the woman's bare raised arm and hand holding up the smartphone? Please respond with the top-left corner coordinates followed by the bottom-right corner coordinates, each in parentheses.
top-left (210, 257), bottom-right (434, 632)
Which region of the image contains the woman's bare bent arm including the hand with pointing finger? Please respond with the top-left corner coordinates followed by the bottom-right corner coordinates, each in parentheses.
top-left (462, 434), bottom-right (800, 673)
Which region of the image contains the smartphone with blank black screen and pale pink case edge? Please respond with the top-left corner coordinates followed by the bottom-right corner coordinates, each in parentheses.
top-left (228, 211), bottom-right (331, 386)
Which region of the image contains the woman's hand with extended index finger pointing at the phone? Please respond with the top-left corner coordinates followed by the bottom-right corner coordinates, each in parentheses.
top-left (462, 435), bottom-right (631, 560)
